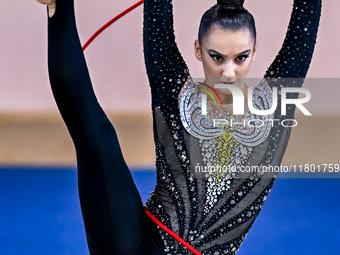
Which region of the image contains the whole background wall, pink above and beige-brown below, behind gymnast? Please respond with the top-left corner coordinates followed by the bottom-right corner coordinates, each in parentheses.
top-left (0, 0), bottom-right (340, 166)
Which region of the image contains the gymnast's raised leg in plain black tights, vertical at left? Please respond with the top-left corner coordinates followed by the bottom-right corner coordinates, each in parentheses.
top-left (42, 0), bottom-right (164, 255)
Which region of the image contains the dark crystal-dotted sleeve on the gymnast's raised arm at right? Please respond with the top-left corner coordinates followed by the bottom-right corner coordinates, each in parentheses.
top-left (265, 0), bottom-right (322, 78)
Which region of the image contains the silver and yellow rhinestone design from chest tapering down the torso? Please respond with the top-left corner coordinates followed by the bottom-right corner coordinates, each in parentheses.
top-left (179, 79), bottom-right (273, 214)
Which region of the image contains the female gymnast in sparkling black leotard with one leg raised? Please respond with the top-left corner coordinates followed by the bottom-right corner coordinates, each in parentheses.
top-left (38, 0), bottom-right (321, 255)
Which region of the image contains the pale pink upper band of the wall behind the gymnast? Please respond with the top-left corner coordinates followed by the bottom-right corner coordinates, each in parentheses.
top-left (0, 0), bottom-right (340, 113)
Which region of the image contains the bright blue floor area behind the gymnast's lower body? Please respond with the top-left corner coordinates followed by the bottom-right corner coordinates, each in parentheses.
top-left (0, 168), bottom-right (340, 255)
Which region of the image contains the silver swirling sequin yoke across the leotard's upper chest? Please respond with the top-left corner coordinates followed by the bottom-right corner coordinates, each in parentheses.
top-left (179, 79), bottom-right (273, 147)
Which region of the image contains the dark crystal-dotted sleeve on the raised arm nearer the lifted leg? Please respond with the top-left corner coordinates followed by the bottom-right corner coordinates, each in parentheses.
top-left (143, 0), bottom-right (189, 106)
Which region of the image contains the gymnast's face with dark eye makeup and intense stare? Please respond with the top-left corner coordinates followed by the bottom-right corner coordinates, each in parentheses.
top-left (195, 26), bottom-right (256, 95)
